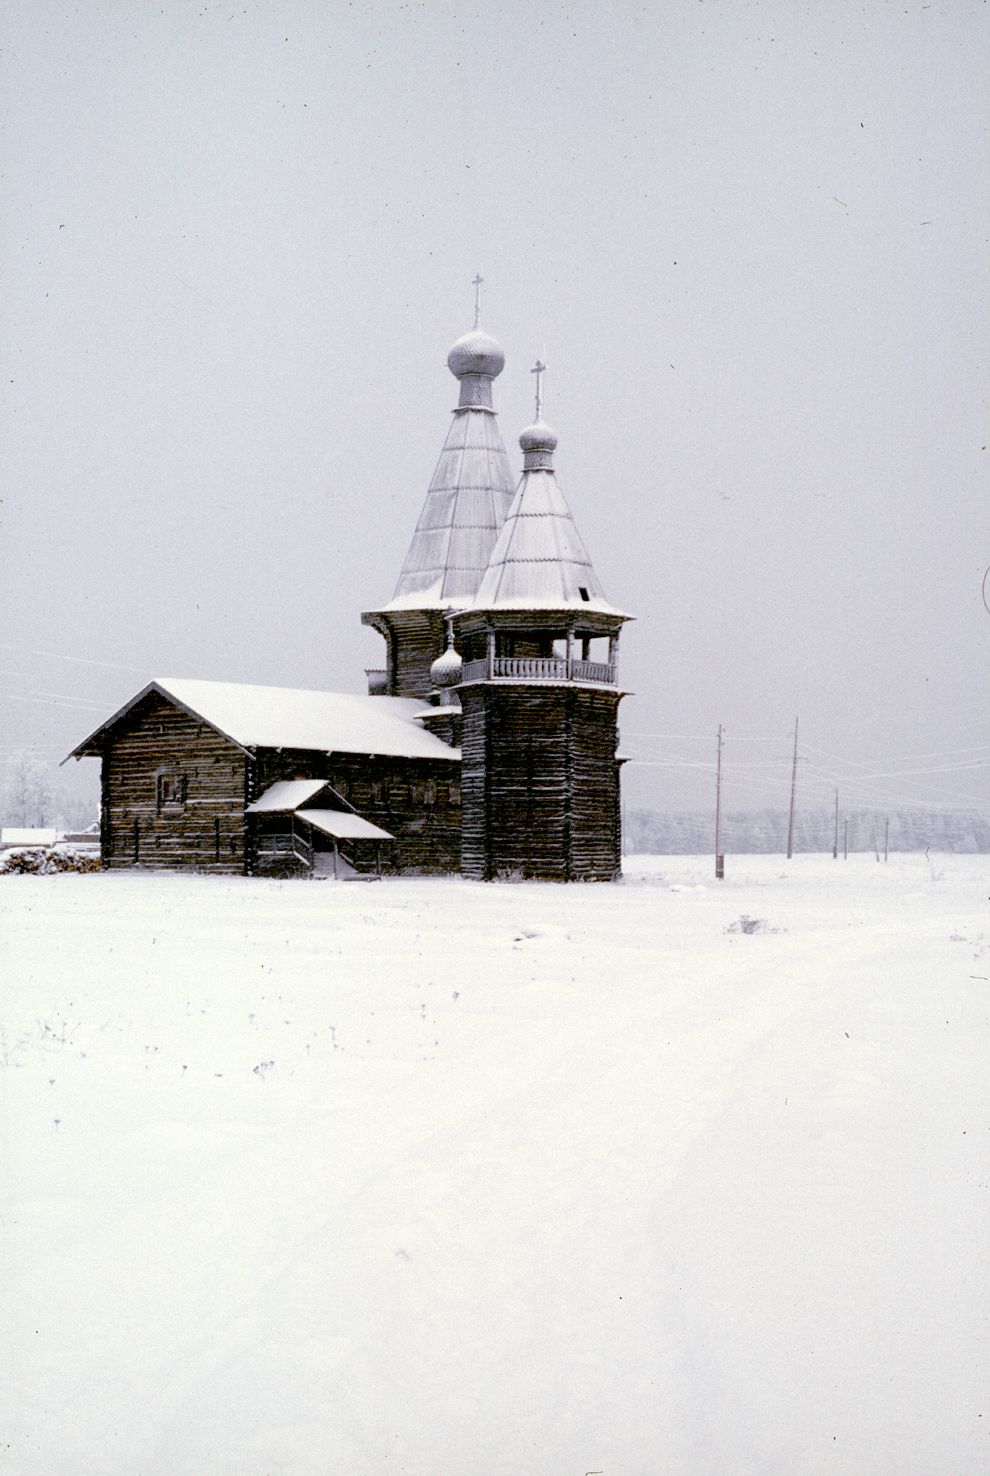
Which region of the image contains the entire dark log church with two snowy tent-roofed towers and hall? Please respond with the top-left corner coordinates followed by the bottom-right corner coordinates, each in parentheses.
top-left (69, 295), bottom-right (629, 881)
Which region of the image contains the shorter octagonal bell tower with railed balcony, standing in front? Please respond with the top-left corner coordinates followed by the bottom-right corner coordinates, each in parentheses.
top-left (451, 362), bottom-right (630, 881)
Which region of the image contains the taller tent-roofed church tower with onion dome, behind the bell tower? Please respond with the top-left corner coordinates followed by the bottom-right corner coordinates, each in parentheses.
top-left (361, 286), bottom-right (512, 698)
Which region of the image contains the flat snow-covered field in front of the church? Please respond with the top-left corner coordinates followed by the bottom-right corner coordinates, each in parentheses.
top-left (0, 855), bottom-right (990, 1476)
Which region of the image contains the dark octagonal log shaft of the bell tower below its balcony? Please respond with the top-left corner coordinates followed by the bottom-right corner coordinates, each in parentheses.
top-left (460, 682), bottom-right (621, 881)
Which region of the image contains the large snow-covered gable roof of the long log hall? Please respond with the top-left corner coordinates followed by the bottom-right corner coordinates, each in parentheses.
top-left (69, 676), bottom-right (460, 763)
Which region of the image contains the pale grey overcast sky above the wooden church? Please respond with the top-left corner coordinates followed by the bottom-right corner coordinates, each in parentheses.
top-left (0, 0), bottom-right (990, 807)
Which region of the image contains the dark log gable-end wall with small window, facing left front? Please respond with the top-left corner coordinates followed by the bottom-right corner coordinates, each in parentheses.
top-left (100, 692), bottom-right (245, 874)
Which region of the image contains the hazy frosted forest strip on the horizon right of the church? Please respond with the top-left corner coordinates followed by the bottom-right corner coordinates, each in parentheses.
top-left (623, 809), bottom-right (990, 856)
